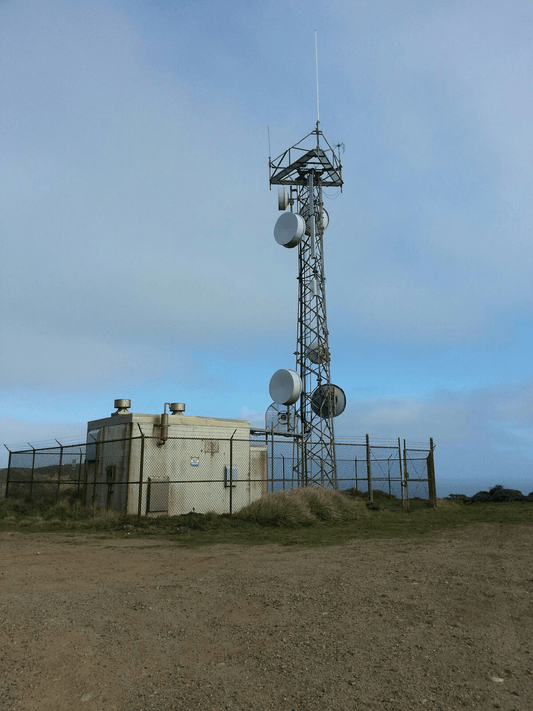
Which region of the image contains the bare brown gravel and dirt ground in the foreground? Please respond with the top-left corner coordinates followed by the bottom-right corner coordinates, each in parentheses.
top-left (0, 524), bottom-right (533, 711)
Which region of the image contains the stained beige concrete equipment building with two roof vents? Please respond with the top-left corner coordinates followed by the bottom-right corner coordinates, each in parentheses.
top-left (86, 400), bottom-right (268, 516)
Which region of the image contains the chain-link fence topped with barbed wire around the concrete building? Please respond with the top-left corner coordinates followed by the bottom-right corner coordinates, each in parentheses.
top-left (4, 431), bottom-right (437, 516)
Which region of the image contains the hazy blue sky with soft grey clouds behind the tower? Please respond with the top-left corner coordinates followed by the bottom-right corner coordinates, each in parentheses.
top-left (0, 0), bottom-right (533, 496)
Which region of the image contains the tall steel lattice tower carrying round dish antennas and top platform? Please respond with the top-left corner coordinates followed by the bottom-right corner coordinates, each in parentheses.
top-left (269, 120), bottom-right (346, 489)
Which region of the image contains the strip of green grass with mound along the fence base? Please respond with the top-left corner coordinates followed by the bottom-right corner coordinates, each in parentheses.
top-left (0, 487), bottom-right (533, 547)
